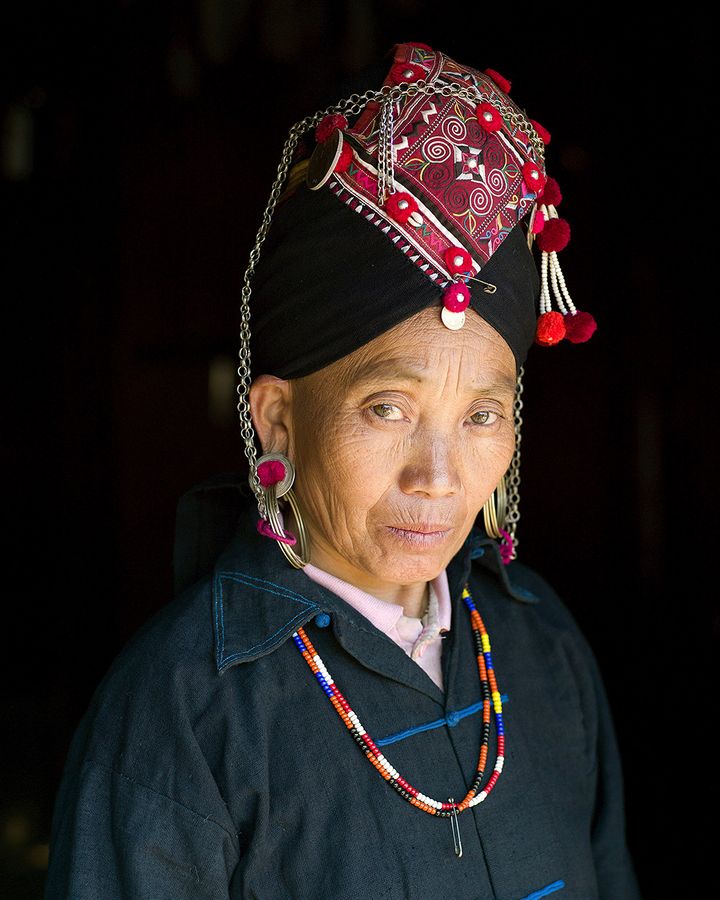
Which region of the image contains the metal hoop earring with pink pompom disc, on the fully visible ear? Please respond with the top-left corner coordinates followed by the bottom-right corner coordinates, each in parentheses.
top-left (251, 453), bottom-right (310, 569)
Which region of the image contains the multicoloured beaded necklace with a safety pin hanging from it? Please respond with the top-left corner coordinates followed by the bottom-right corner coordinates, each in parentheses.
top-left (293, 585), bottom-right (505, 856)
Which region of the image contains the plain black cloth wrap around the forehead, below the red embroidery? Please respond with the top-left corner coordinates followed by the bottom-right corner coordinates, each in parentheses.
top-left (251, 185), bottom-right (539, 378)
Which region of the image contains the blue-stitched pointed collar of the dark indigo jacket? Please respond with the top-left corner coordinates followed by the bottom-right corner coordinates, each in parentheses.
top-left (212, 503), bottom-right (537, 684)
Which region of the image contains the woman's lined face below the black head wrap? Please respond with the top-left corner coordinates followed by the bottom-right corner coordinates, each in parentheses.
top-left (265, 309), bottom-right (516, 589)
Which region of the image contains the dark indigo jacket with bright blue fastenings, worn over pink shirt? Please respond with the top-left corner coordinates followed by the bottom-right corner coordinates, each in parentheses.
top-left (46, 482), bottom-right (639, 900)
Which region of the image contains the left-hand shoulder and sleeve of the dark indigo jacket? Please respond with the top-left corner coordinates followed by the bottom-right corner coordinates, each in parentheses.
top-left (45, 579), bottom-right (239, 900)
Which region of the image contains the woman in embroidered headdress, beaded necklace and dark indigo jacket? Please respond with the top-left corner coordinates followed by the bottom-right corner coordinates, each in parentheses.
top-left (47, 44), bottom-right (638, 900)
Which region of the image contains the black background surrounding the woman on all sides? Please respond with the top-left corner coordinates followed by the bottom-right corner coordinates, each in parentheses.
top-left (0, 0), bottom-right (718, 898)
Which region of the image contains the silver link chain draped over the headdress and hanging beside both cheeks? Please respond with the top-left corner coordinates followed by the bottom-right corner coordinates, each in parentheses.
top-left (237, 81), bottom-right (545, 516)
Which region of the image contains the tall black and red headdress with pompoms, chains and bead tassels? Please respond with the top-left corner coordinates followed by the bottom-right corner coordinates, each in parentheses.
top-left (238, 43), bottom-right (595, 557)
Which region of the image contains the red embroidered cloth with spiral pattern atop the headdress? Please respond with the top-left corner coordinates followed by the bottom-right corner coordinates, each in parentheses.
top-left (328, 44), bottom-right (545, 285)
